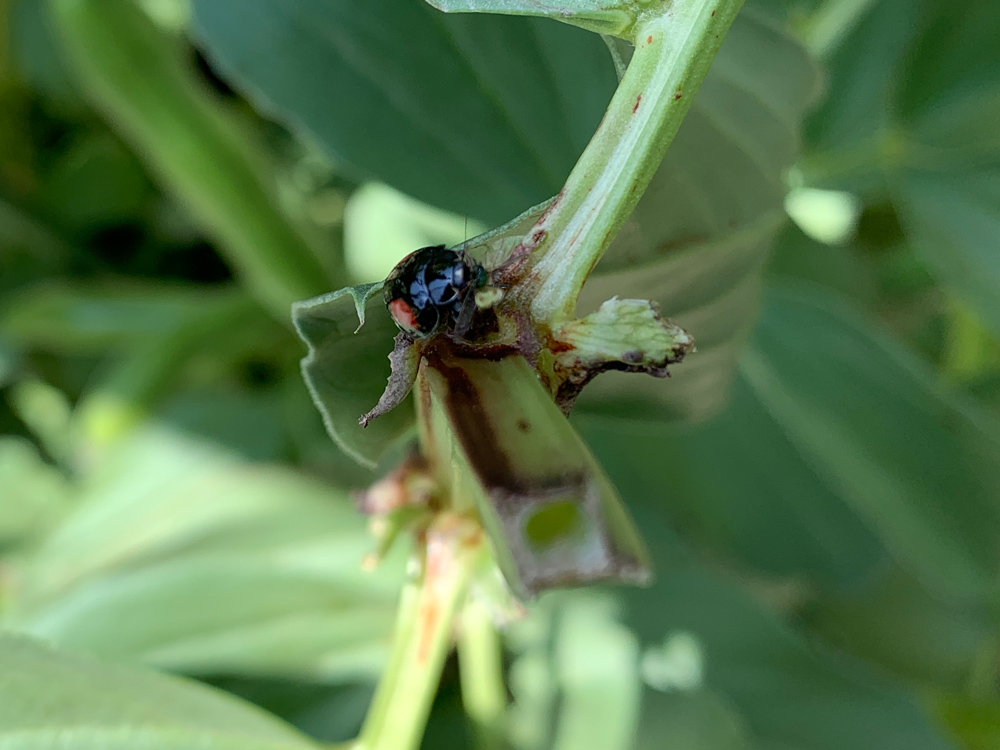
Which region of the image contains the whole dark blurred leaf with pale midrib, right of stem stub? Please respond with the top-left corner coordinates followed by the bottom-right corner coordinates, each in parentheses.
top-left (578, 287), bottom-right (1000, 596)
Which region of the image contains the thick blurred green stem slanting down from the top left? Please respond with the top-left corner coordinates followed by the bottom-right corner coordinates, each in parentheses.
top-left (49, 0), bottom-right (345, 323)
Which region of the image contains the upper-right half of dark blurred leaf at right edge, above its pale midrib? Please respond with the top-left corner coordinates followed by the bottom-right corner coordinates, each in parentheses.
top-left (741, 290), bottom-right (1000, 596)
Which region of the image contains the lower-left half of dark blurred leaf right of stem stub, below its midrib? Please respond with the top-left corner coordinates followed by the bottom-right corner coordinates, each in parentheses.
top-left (574, 374), bottom-right (886, 588)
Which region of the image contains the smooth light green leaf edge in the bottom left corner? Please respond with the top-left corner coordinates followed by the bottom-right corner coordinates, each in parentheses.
top-left (0, 635), bottom-right (316, 750)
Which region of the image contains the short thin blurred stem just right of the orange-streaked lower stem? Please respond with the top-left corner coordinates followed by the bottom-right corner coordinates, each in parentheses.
top-left (458, 601), bottom-right (507, 750)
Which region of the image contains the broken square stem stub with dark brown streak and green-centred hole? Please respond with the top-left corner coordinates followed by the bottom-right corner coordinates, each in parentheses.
top-left (417, 350), bottom-right (651, 599)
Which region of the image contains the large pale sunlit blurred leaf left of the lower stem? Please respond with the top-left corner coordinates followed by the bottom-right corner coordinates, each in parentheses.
top-left (5, 430), bottom-right (401, 680)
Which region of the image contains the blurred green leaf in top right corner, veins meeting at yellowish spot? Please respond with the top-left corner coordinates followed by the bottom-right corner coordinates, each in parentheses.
top-left (803, 0), bottom-right (1000, 332)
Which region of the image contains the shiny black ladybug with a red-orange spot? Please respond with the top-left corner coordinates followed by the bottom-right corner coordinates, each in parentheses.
top-left (382, 245), bottom-right (489, 338)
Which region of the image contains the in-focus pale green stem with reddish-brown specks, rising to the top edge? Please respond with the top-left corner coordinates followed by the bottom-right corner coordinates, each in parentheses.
top-left (526, 0), bottom-right (743, 322)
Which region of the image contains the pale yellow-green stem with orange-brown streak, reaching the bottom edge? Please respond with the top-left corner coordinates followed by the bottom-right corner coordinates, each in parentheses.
top-left (355, 513), bottom-right (482, 750)
